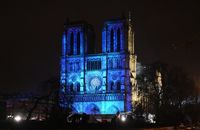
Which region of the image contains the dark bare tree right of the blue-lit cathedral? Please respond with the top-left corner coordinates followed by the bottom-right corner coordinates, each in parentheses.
top-left (137, 62), bottom-right (196, 122)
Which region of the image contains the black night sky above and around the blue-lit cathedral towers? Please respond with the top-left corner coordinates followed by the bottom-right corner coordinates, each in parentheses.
top-left (0, 0), bottom-right (200, 93)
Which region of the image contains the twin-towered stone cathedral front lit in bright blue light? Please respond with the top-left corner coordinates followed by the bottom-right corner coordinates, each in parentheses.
top-left (60, 16), bottom-right (136, 114)
